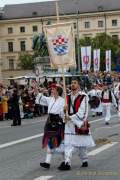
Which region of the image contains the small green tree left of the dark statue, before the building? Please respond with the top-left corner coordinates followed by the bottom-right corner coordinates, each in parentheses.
top-left (19, 52), bottom-right (34, 69)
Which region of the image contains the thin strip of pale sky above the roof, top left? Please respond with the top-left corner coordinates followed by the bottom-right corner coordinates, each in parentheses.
top-left (0, 0), bottom-right (53, 7)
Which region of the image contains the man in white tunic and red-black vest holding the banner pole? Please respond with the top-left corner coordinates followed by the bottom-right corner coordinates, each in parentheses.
top-left (58, 78), bottom-right (95, 170)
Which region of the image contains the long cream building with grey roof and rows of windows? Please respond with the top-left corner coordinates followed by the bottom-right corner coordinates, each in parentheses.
top-left (0, 0), bottom-right (120, 77)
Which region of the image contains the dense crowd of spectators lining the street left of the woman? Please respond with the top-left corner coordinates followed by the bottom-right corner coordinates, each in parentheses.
top-left (0, 84), bottom-right (47, 120)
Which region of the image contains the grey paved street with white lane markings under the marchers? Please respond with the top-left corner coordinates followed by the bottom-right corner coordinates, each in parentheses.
top-left (0, 112), bottom-right (120, 180)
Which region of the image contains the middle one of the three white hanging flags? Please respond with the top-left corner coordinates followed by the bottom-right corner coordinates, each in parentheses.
top-left (93, 49), bottom-right (100, 72)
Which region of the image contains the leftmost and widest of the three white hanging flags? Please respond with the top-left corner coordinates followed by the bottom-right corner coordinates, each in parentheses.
top-left (81, 46), bottom-right (91, 71)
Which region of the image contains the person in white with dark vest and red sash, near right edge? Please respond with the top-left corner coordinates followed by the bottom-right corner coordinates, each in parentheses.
top-left (101, 82), bottom-right (117, 125)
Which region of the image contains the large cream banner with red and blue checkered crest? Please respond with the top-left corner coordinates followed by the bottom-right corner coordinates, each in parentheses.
top-left (45, 22), bottom-right (76, 68)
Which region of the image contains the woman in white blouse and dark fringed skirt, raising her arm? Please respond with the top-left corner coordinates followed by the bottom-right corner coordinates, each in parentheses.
top-left (39, 85), bottom-right (64, 169)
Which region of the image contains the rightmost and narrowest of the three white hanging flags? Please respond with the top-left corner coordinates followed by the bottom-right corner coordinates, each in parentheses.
top-left (105, 50), bottom-right (111, 72)
